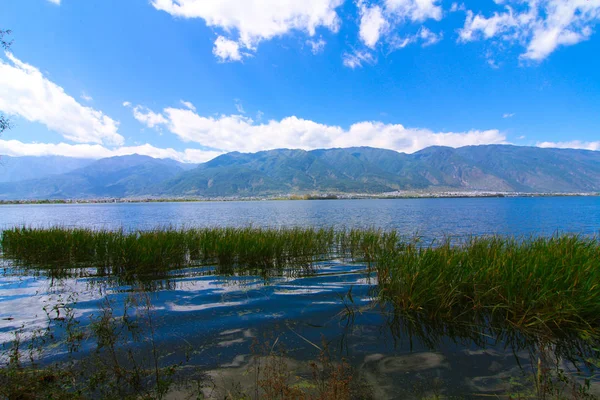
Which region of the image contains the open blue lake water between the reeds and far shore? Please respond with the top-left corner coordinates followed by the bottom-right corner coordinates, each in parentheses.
top-left (0, 197), bottom-right (600, 238)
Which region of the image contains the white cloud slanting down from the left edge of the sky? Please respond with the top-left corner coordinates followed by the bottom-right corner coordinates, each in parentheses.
top-left (0, 53), bottom-right (124, 145)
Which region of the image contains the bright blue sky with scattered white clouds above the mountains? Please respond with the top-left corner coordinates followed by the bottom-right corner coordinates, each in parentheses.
top-left (0, 0), bottom-right (600, 163)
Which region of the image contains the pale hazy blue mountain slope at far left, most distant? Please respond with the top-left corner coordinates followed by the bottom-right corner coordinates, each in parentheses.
top-left (0, 156), bottom-right (95, 182)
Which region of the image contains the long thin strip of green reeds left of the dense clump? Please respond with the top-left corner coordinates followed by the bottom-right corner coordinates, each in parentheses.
top-left (0, 227), bottom-right (398, 277)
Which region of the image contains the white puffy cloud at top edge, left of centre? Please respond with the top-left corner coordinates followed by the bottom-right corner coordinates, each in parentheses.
top-left (151, 0), bottom-right (344, 61)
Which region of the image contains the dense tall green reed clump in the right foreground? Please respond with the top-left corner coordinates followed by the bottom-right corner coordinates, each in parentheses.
top-left (376, 235), bottom-right (600, 337)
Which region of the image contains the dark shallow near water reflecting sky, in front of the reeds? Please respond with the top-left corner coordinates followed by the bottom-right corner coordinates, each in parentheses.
top-left (0, 262), bottom-right (600, 399)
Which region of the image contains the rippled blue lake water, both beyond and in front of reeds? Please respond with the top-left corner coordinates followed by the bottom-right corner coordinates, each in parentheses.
top-left (0, 197), bottom-right (600, 398)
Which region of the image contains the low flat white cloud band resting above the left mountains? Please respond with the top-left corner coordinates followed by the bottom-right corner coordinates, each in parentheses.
top-left (0, 140), bottom-right (223, 163)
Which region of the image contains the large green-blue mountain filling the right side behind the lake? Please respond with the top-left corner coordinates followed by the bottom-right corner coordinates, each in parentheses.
top-left (157, 145), bottom-right (600, 197)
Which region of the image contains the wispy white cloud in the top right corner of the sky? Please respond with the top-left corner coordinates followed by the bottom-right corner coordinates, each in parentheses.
top-left (459, 0), bottom-right (600, 61)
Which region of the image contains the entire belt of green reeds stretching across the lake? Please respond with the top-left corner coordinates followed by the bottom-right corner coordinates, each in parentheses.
top-left (0, 227), bottom-right (600, 337)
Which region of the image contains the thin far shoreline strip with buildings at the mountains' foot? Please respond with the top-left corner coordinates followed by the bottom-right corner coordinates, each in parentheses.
top-left (0, 191), bottom-right (600, 205)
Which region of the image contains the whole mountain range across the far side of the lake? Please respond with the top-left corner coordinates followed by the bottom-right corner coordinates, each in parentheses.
top-left (0, 145), bottom-right (600, 200)
